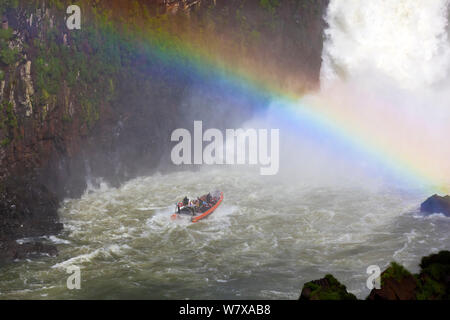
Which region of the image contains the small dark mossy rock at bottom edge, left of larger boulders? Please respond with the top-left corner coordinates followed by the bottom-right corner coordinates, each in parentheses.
top-left (299, 274), bottom-right (356, 300)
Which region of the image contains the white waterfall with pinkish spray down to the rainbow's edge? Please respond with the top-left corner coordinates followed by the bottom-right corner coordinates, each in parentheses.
top-left (319, 0), bottom-right (450, 187)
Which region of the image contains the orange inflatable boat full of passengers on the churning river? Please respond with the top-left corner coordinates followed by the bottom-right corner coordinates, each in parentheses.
top-left (171, 191), bottom-right (223, 222)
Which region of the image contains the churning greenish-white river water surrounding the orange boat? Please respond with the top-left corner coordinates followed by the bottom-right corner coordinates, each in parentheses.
top-left (0, 168), bottom-right (450, 299)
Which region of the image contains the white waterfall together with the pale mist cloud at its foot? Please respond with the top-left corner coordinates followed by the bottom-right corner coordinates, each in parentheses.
top-left (239, 0), bottom-right (450, 191)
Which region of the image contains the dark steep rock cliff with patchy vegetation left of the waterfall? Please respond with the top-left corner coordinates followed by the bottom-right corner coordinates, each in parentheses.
top-left (0, 0), bottom-right (327, 260)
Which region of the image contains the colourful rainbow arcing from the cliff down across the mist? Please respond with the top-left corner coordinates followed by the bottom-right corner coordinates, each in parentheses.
top-left (89, 4), bottom-right (450, 193)
